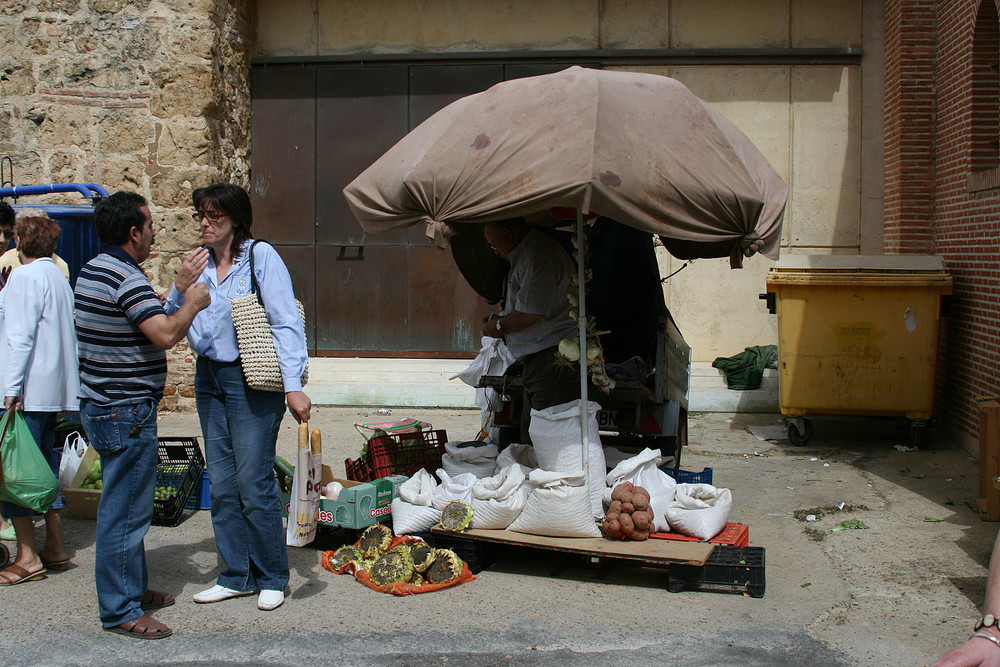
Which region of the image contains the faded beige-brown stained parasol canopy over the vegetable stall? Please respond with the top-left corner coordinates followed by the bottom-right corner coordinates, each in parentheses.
top-left (344, 67), bottom-right (788, 274)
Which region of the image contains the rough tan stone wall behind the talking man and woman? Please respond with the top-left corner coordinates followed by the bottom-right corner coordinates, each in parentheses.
top-left (0, 0), bottom-right (253, 408)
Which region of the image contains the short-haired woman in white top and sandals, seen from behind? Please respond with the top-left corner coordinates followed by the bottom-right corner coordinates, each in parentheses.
top-left (0, 209), bottom-right (80, 586)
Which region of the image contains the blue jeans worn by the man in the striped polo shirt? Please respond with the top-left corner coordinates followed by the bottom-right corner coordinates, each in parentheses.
top-left (80, 399), bottom-right (159, 628)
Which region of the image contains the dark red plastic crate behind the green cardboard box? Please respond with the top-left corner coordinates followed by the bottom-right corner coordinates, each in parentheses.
top-left (344, 429), bottom-right (448, 482)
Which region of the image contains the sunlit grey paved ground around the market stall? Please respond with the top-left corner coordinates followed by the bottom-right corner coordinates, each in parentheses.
top-left (0, 408), bottom-right (997, 667)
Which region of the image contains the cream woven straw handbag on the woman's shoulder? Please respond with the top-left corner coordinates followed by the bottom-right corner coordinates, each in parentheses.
top-left (232, 239), bottom-right (309, 392)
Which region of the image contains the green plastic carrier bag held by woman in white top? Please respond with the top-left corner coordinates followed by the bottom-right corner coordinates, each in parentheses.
top-left (0, 409), bottom-right (59, 512)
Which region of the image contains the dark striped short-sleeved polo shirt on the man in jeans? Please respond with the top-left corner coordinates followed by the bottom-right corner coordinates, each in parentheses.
top-left (76, 246), bottom-right (167, 405)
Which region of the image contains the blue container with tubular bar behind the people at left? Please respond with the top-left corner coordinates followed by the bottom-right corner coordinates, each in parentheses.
top-left (0, 183), bottom-right (108, 287)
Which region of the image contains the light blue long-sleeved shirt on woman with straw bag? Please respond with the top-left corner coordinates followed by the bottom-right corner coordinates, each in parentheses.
top-left (163, 239), bottom-right (308, 392)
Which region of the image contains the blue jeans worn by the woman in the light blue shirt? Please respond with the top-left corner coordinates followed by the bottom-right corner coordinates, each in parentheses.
top-left (194, 357), bottom-right (288, 591)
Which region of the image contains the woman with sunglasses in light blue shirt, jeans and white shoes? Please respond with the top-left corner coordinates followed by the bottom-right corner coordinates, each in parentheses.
top-left (164, 183), bottom-right (312, 611)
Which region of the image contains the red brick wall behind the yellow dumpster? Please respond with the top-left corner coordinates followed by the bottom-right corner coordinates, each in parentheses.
top-left (885, 0), bottom-right (1000, 446)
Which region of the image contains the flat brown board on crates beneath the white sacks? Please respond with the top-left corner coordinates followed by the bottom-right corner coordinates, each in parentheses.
top-left (431, 528), bottom-right (715, 566)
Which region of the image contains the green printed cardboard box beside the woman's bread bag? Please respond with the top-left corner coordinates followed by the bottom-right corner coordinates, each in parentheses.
top-left (280, 465), bottom-right (409, 528)
